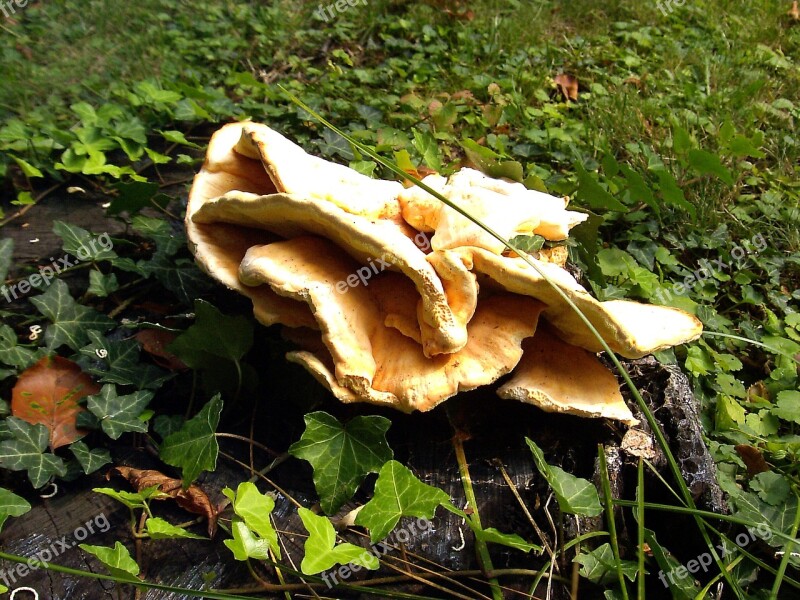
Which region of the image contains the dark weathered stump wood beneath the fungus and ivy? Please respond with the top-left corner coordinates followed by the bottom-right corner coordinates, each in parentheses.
top-left (0, 190), bottom-right (724, 600)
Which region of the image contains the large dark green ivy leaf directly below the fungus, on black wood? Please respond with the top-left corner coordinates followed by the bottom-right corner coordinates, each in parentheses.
top-left (289, 412), bottom-right (393, 515)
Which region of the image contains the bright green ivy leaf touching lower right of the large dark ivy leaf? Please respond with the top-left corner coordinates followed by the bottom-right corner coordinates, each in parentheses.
top-left (356, 460), bottom-right (450, 542)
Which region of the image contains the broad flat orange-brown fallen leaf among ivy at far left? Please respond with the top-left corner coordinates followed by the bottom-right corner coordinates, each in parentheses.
top-left (11, 356), bottom-right (100, 450)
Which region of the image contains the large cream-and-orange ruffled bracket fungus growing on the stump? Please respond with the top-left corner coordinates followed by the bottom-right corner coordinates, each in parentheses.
top-left (186, 122), bottom-right (702, 424)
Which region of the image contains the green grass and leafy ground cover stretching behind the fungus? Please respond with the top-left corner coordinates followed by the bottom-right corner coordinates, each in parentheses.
top-left (0, 0), bottom-right (800, 597)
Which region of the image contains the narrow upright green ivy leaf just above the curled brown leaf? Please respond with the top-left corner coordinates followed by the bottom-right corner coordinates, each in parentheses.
top-left (159, 394), bottom-right (222, 488)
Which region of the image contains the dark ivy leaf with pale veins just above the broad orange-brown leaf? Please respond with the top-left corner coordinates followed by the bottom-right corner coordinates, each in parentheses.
top-left (30, 279), bottom-right (116, 350)
